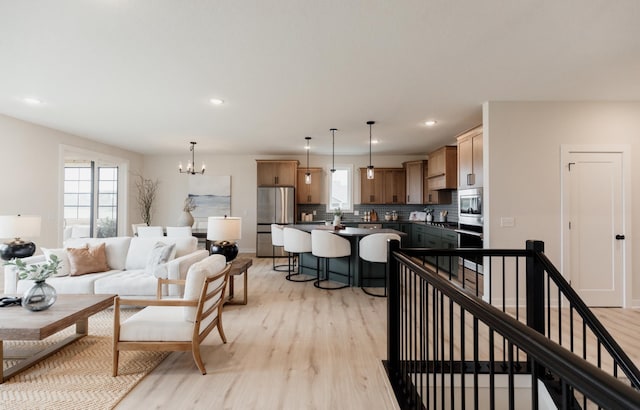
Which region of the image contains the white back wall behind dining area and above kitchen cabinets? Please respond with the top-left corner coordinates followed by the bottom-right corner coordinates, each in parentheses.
top-left (142, 152), bottom-right (428, 252)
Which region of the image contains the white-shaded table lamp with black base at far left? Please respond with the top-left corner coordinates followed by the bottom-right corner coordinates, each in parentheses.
top-left (0, 215), bottom-right (41, 261)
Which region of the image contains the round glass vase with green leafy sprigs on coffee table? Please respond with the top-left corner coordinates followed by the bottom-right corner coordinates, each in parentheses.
top-left (4, 255), bottom-right (60, 311)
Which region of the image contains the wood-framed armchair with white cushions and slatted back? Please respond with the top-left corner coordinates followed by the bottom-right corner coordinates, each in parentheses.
top-left (113, 255), bottom-right (231, 376)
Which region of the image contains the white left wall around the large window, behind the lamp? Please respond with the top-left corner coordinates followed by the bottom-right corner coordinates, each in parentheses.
top-left (0, 115), bottom-right (143, 250)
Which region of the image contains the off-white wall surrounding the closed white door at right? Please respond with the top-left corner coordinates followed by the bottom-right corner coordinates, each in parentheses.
top-left (484, 102), bottom-right (640, 306)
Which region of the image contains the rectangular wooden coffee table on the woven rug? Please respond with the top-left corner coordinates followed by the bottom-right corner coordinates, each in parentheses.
top-left (0, 295), bottom-right (115, 383)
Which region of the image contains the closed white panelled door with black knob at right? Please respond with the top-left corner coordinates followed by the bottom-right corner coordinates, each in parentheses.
top-left (563, 152), bottom-right (625, 307)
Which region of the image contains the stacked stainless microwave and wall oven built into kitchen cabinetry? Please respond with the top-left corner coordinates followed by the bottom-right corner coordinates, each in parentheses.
top-left (456, 188), bottom-right (484, 273)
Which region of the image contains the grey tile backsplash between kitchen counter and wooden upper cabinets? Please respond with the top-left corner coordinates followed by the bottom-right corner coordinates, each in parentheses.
top-left (296, 190), bottom-right (458, 223)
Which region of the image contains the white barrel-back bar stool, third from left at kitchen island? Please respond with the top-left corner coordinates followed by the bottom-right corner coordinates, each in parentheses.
top-left (311, 229), bottom-right (351, 290)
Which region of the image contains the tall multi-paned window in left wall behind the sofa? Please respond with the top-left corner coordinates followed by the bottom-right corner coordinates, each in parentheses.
top-left (63, 161), bottom-right (118, 239)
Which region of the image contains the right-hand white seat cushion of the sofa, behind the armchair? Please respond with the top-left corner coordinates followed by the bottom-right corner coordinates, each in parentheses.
top-left (94, 269), bottom-right (158, 297)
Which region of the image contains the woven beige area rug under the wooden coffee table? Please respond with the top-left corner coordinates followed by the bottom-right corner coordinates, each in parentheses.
top-left (0, 309), bottom-right (168, 410)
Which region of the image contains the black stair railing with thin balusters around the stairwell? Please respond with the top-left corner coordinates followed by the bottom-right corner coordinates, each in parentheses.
top-left (385, 241), bottom-right (640, 409)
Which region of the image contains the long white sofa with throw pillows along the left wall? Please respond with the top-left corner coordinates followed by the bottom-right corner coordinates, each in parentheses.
top-left (4, 236), bottom-right (209, 297)
